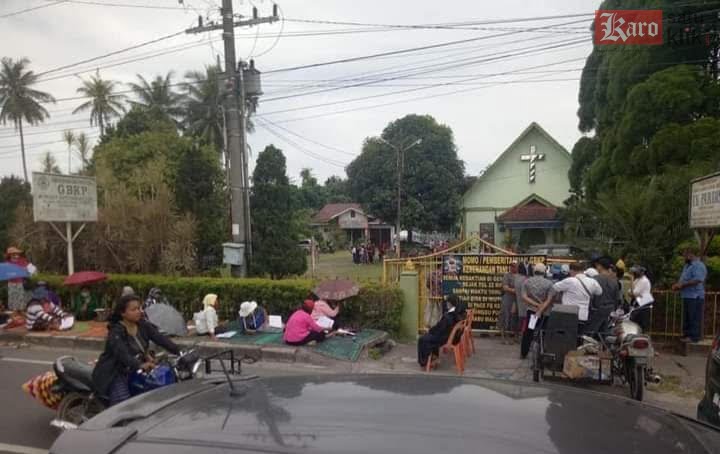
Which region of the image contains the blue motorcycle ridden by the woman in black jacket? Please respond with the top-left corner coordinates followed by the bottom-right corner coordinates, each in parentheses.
top-left (50, 349), bottom-right (202, 430)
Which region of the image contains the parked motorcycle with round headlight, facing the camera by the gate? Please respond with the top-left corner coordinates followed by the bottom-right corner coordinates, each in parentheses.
top-left (581, 310), bottom-right (662, 401)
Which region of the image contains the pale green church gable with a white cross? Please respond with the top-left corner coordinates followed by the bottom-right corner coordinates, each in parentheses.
top-left (463, 122), bottom-right (571, 209)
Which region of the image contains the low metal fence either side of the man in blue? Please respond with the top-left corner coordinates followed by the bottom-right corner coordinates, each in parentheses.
top-left (650, 290), bottom-right (720, 339)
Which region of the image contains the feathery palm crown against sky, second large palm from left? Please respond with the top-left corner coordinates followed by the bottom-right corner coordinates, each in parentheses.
top-left (73, 71), bottom-right (126, 136)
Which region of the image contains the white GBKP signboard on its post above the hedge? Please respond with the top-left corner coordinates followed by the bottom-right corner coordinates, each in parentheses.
top-left (32, 172), bottom-right (97, 275)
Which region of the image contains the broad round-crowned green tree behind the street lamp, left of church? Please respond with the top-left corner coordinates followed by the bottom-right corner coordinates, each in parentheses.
top-left (347, 115), bottom-right (464, 232)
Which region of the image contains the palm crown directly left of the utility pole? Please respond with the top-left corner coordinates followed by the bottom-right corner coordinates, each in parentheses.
top-left (184, 66), bottom-right (224, 151)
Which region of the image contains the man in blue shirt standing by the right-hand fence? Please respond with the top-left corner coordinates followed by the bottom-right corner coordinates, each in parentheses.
top-left (672, 246), bottom-right (707, 342)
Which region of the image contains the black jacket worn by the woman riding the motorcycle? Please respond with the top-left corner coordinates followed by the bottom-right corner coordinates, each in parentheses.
top-left (92, 320), bottom-right (180, 397)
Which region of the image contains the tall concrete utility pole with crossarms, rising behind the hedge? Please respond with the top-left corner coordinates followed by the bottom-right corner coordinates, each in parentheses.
top-left (186, 0), bottom-right (280, 277)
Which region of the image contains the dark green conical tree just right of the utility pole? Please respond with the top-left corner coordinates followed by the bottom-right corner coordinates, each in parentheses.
top-left (250, 145), bottom-right (307, 279)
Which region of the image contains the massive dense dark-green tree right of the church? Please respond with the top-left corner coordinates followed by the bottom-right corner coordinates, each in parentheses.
top-left (565, 0), bottom-right (720, 278)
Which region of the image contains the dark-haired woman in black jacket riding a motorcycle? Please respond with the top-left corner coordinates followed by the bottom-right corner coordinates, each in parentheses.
top-left (92, 295), bottom-right (180, 406)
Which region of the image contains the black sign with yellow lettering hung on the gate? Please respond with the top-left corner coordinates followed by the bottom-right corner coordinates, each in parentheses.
top-left (442, 254), bottom-right (547, 331)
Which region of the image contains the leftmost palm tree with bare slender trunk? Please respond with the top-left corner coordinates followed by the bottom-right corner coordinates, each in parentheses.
top-left (0, 57), bottom-right (55, 181)
